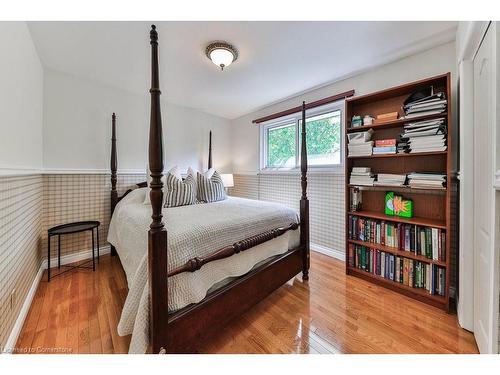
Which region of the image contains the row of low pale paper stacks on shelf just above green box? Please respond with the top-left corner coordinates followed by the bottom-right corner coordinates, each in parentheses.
top-left (349, 167), bottom-right (446, 190)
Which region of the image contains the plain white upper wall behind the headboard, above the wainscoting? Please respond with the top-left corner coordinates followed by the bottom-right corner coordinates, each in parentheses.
top-left (43, 69), bottom-right (232, 172)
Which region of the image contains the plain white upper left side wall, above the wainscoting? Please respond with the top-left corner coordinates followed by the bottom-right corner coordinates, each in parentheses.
top-left (0, 22), bottom-right (43, 169)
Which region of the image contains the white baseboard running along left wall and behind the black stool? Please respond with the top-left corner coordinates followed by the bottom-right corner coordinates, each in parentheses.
top-left (1, 245), bottom-right (111, 354)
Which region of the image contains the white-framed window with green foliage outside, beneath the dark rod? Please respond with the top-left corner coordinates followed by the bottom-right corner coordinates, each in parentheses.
top-left (261, 101), bottom-right (344, 169)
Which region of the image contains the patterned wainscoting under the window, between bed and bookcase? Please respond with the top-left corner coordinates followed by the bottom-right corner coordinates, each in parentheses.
top-left (231, 172), bottom-right (345, 256)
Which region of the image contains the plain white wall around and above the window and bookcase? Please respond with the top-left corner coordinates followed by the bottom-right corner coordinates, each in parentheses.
top-left (232, 42), bottom-right (457, 173)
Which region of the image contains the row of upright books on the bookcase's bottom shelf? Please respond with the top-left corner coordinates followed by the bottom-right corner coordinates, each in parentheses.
top-left (348, 244), bottom-right (446, 296)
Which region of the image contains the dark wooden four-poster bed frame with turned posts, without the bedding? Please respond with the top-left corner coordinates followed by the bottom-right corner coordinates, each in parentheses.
top-left (111, 25), bottom-right (309, 353)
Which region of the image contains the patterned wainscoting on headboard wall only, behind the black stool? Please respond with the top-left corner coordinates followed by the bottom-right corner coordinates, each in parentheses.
top-left (41, 174), bottom-right (146, 259)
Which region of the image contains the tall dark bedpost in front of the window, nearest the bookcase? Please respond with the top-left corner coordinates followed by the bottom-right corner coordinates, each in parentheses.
top-left (300, 102), bottom-right (310, 280)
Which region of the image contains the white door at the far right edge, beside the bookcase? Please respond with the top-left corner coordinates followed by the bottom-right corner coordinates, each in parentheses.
top-left (474, 26), bottom-right (498, 353)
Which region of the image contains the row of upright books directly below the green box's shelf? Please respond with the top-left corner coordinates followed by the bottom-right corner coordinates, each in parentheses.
top-left (348, 216), bottom-right (446, 262)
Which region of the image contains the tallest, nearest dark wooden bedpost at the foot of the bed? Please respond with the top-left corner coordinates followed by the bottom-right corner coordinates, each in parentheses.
top-left (148, 25), bottom-right (168, 353)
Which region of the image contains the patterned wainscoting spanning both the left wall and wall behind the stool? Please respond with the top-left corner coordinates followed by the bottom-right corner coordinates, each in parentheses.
top-left (0, 174), bottom-right (146, 352)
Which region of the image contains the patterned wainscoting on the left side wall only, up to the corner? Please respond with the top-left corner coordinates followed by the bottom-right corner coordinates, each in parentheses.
top-left (0, 175), bottom-right (43, 353)
